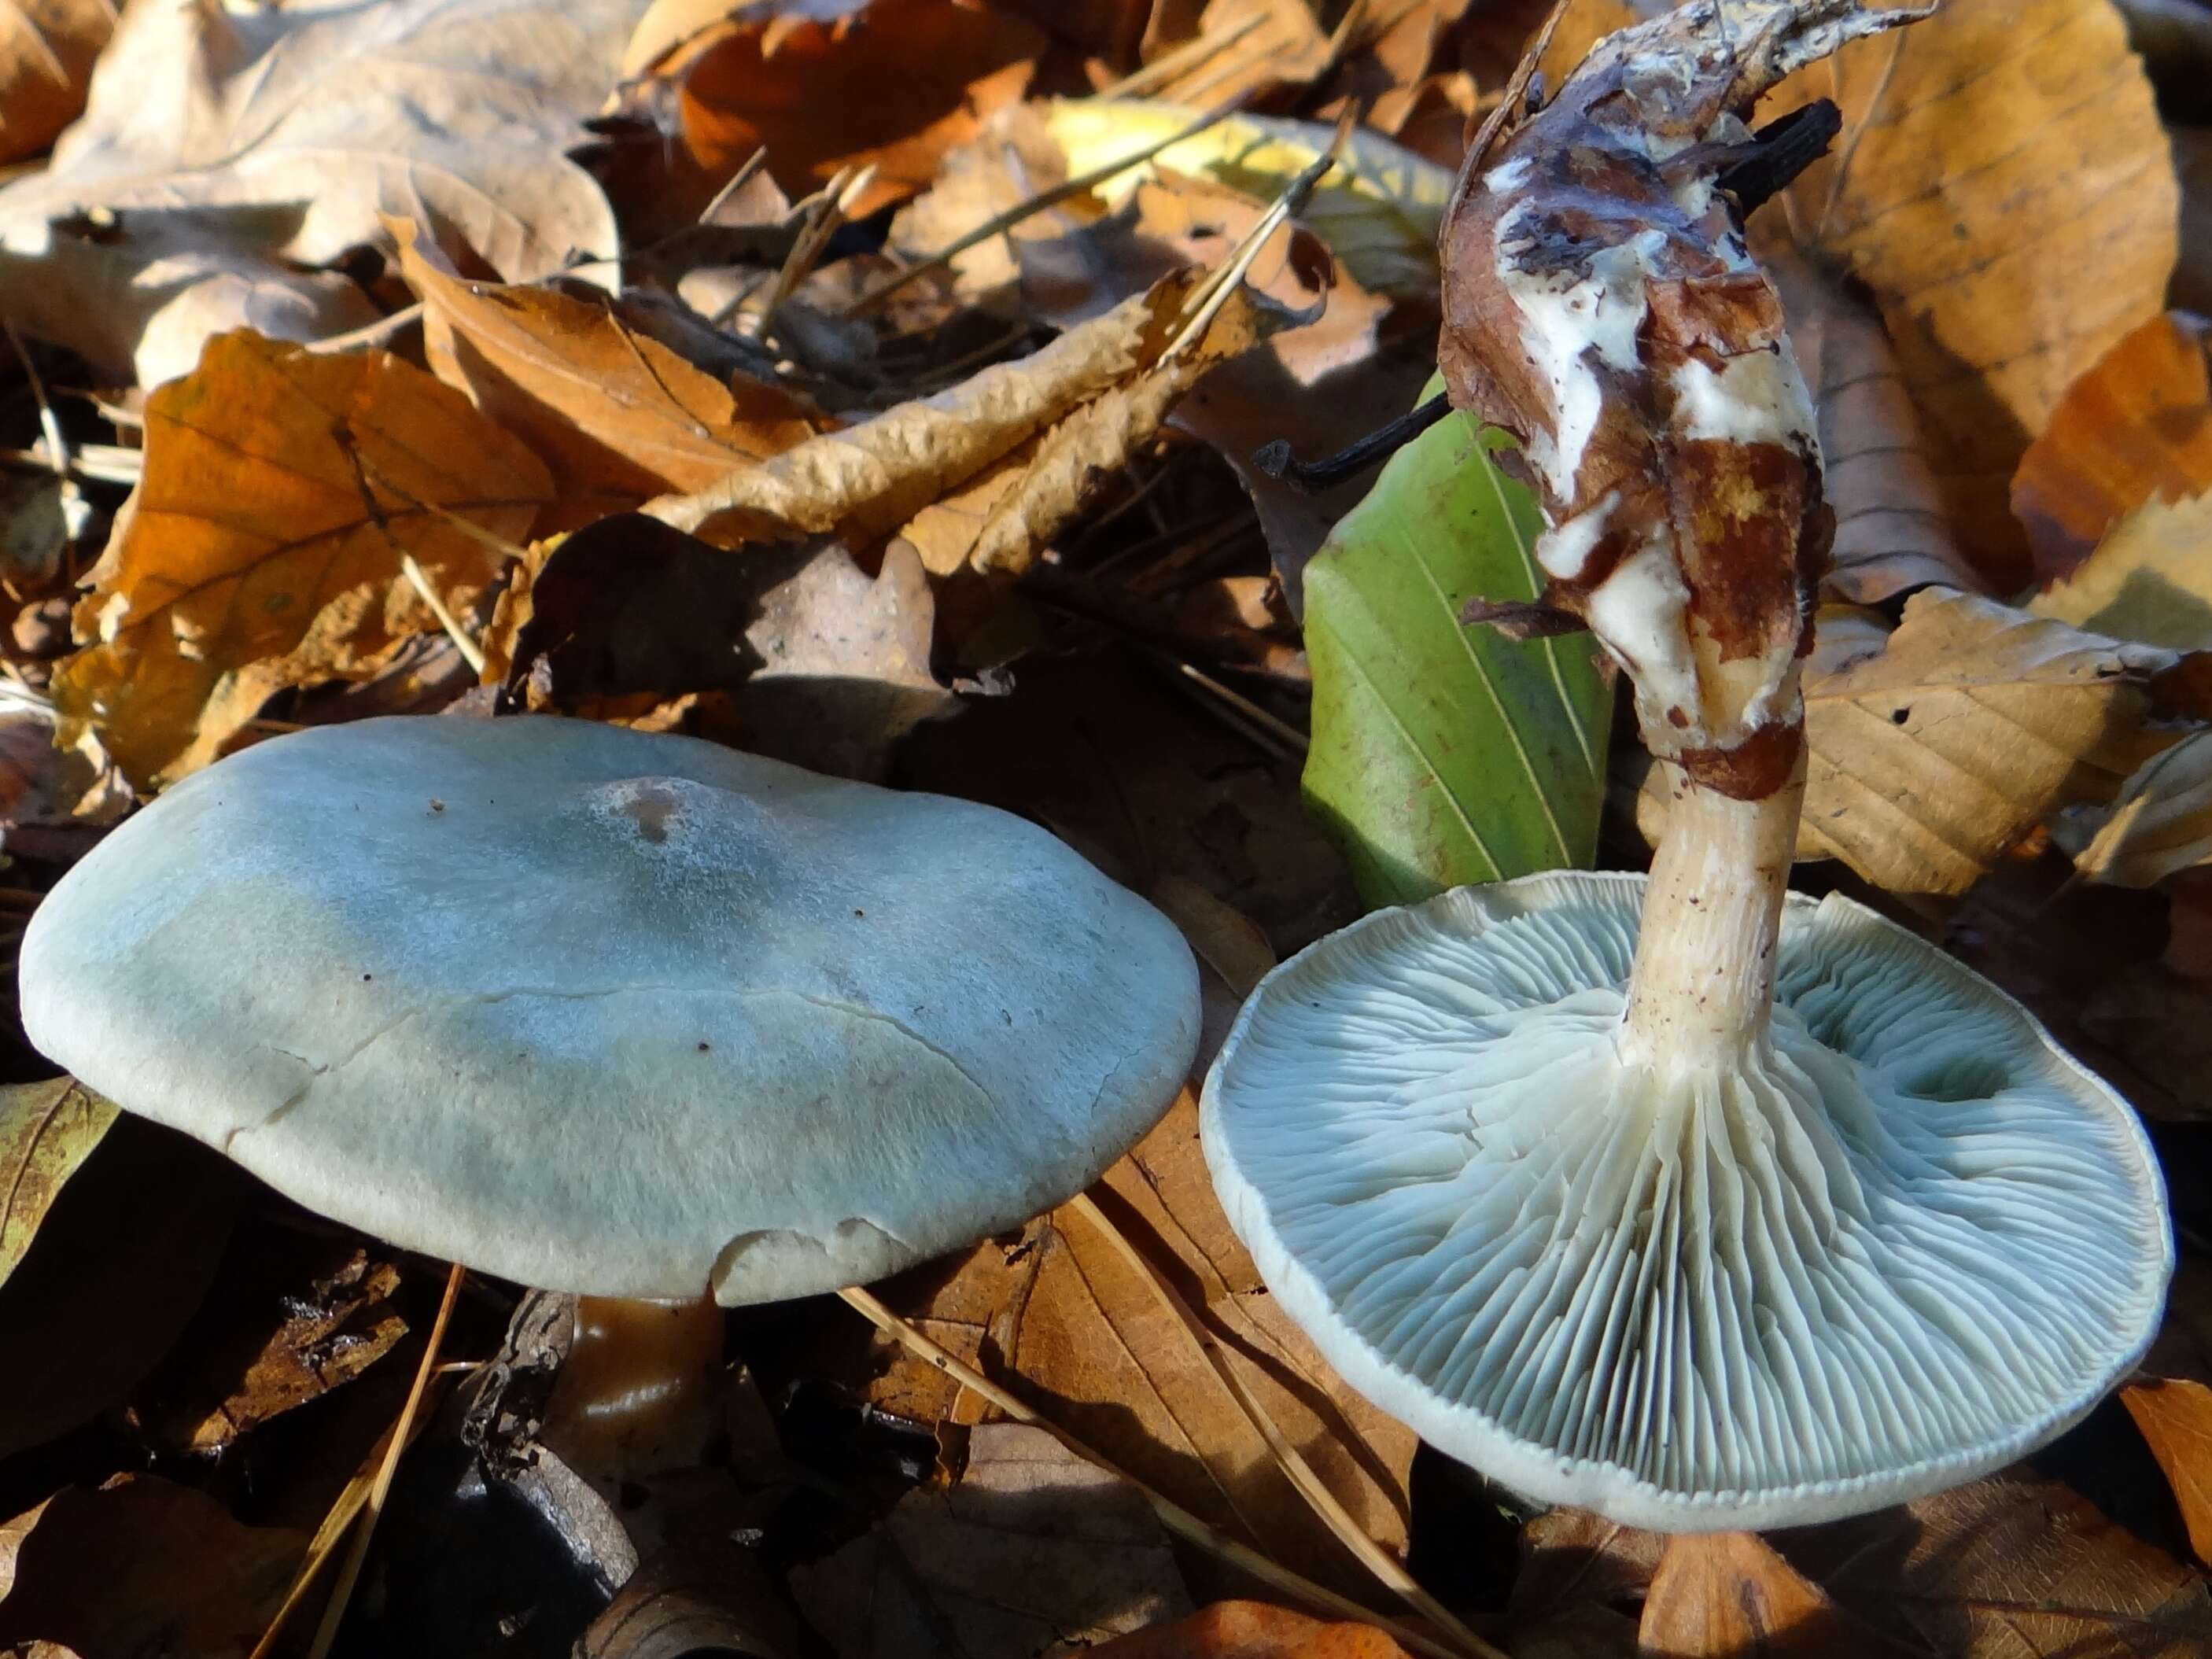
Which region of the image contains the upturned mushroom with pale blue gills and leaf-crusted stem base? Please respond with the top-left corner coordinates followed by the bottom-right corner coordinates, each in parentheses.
top-left (1201, 0), bottom-right (2172, 1531)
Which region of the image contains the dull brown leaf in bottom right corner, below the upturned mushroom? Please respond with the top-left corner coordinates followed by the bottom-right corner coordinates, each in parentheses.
top-left (1774, 1471), bottom-right (2212, 1659)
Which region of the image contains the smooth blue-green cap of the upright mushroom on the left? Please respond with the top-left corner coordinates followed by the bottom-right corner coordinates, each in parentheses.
top-left (22, 717), bottom-right (1199, 1303)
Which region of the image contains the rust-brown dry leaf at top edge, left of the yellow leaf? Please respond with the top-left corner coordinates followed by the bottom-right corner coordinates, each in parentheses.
top-left (624, 0), bottom-right (1046, 215)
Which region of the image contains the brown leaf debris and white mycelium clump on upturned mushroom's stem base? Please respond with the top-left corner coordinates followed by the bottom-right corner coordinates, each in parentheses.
top-left (1438, 0), bottom-right (1918, 801)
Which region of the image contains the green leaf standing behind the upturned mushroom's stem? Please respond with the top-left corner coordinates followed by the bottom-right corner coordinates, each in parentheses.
top-left (1305, 381), bottom-right (1613, 905)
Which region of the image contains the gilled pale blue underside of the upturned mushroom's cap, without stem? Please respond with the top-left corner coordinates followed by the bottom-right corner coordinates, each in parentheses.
top-left (1201, 874), bottom-right (2172, 1531)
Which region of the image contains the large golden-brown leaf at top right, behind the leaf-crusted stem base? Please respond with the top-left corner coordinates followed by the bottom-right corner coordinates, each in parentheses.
top-left (1760, 0), bottom-right (2179, 593)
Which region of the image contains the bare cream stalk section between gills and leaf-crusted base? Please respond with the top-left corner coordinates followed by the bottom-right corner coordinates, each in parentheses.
top-left (1619, 761), bottom-right (1805, 1071)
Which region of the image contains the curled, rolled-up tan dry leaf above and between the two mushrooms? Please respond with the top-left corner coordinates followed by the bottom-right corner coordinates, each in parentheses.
top-left (646, 272), bottom-right (1277, 569)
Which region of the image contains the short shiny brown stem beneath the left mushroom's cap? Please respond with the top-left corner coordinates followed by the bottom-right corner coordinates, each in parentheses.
top-left (540, 1296), bottom-right (724, 1480)
